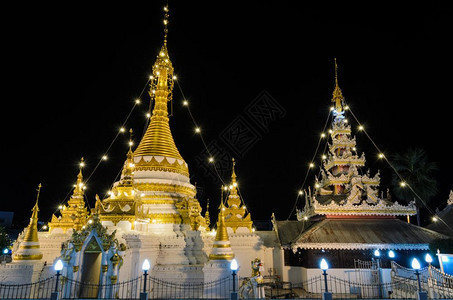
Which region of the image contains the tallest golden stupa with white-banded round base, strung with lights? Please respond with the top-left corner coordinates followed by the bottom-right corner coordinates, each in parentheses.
top-left (97, 7), bottom-right (207, 231)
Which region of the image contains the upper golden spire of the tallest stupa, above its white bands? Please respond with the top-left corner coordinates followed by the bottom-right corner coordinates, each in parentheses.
top-left (134, 6), bottom-right (183, 160)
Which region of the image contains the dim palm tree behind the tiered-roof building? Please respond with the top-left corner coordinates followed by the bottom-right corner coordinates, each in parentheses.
top-left (391, 148), bottom-right (438, 226)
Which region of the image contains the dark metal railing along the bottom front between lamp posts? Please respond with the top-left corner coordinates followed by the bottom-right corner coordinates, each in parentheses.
top-left (0, 266), bottom-right (453, 299)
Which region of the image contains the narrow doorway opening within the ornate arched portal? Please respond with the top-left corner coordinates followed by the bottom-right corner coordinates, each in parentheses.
top-left (79, 237), bottom-right (102, 298)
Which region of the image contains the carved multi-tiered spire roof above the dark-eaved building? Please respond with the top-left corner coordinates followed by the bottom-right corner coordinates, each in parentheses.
top-left (298, 62), bottom-right (416, 218)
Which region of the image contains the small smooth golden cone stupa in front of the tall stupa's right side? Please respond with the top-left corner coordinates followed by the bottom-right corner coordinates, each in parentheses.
top-left (209, 202), bottom-right (234, 260)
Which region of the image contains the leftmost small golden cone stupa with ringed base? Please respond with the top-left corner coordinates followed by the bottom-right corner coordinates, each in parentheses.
top-left (13, 184), bottom-right (43, 261)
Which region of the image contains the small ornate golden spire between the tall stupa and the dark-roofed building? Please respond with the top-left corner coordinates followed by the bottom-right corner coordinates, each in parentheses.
top-left (225, 158), bottom-right (253, 232)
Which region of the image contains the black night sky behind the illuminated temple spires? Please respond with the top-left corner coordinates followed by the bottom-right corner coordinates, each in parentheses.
top-left (0, 1), bottom-right (453, 226)
